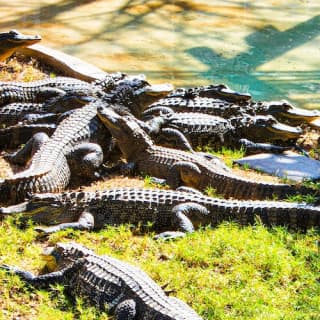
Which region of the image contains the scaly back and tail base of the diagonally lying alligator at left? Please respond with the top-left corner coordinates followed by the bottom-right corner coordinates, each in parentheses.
top-left (0, 103), bottom-right (105, 203)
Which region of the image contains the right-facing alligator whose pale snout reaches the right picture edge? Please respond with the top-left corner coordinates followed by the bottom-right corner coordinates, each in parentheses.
top-left (142, 95), bottom-right (320, 126)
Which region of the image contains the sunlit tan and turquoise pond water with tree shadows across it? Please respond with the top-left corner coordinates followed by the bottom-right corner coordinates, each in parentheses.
top-left (0, 0), bottom-right (320, 108)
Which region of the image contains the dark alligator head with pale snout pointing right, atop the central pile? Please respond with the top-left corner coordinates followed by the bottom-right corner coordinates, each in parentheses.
top-left (107, 75), bottom-right (173, 118)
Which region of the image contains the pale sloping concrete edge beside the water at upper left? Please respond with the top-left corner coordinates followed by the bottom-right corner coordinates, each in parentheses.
top-left (17, 44), bottom-right (107, 82)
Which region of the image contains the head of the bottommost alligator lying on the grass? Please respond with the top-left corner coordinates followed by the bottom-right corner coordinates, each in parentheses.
top-left (42, 242), bottom-right (92, 271)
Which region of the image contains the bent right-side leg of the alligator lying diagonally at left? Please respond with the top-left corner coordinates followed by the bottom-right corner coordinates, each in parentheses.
top-left (67, 142), bottom-right (103, 180)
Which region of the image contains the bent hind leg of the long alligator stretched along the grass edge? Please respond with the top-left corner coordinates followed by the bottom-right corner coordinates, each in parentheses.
top-left (156, 202), bottom-right (210, 240)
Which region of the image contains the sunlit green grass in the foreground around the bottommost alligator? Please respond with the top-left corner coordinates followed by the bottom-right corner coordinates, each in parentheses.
top-left (0, 219), bottom-right (320, 319)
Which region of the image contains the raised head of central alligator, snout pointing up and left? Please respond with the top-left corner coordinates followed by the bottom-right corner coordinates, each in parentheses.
top-left (97, 106), bottom-right (153, 161)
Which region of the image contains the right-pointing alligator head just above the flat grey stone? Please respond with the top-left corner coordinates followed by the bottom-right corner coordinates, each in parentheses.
top-left (233, 115), bottom-right (303, 142)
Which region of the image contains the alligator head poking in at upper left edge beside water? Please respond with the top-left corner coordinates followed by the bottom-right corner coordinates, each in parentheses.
top-left (0, 30), bottom-right (41, 61)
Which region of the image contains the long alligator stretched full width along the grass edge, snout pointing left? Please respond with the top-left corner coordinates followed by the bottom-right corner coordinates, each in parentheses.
top-left (0, 188), bottom-right (320, 238)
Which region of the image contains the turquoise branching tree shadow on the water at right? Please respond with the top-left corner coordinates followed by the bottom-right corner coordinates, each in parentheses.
top-left (185, 15), bottom-right (320, 102)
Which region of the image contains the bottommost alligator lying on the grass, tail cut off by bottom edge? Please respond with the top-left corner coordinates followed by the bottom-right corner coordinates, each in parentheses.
top-left (1, 242), bottom-right (202, 320)
